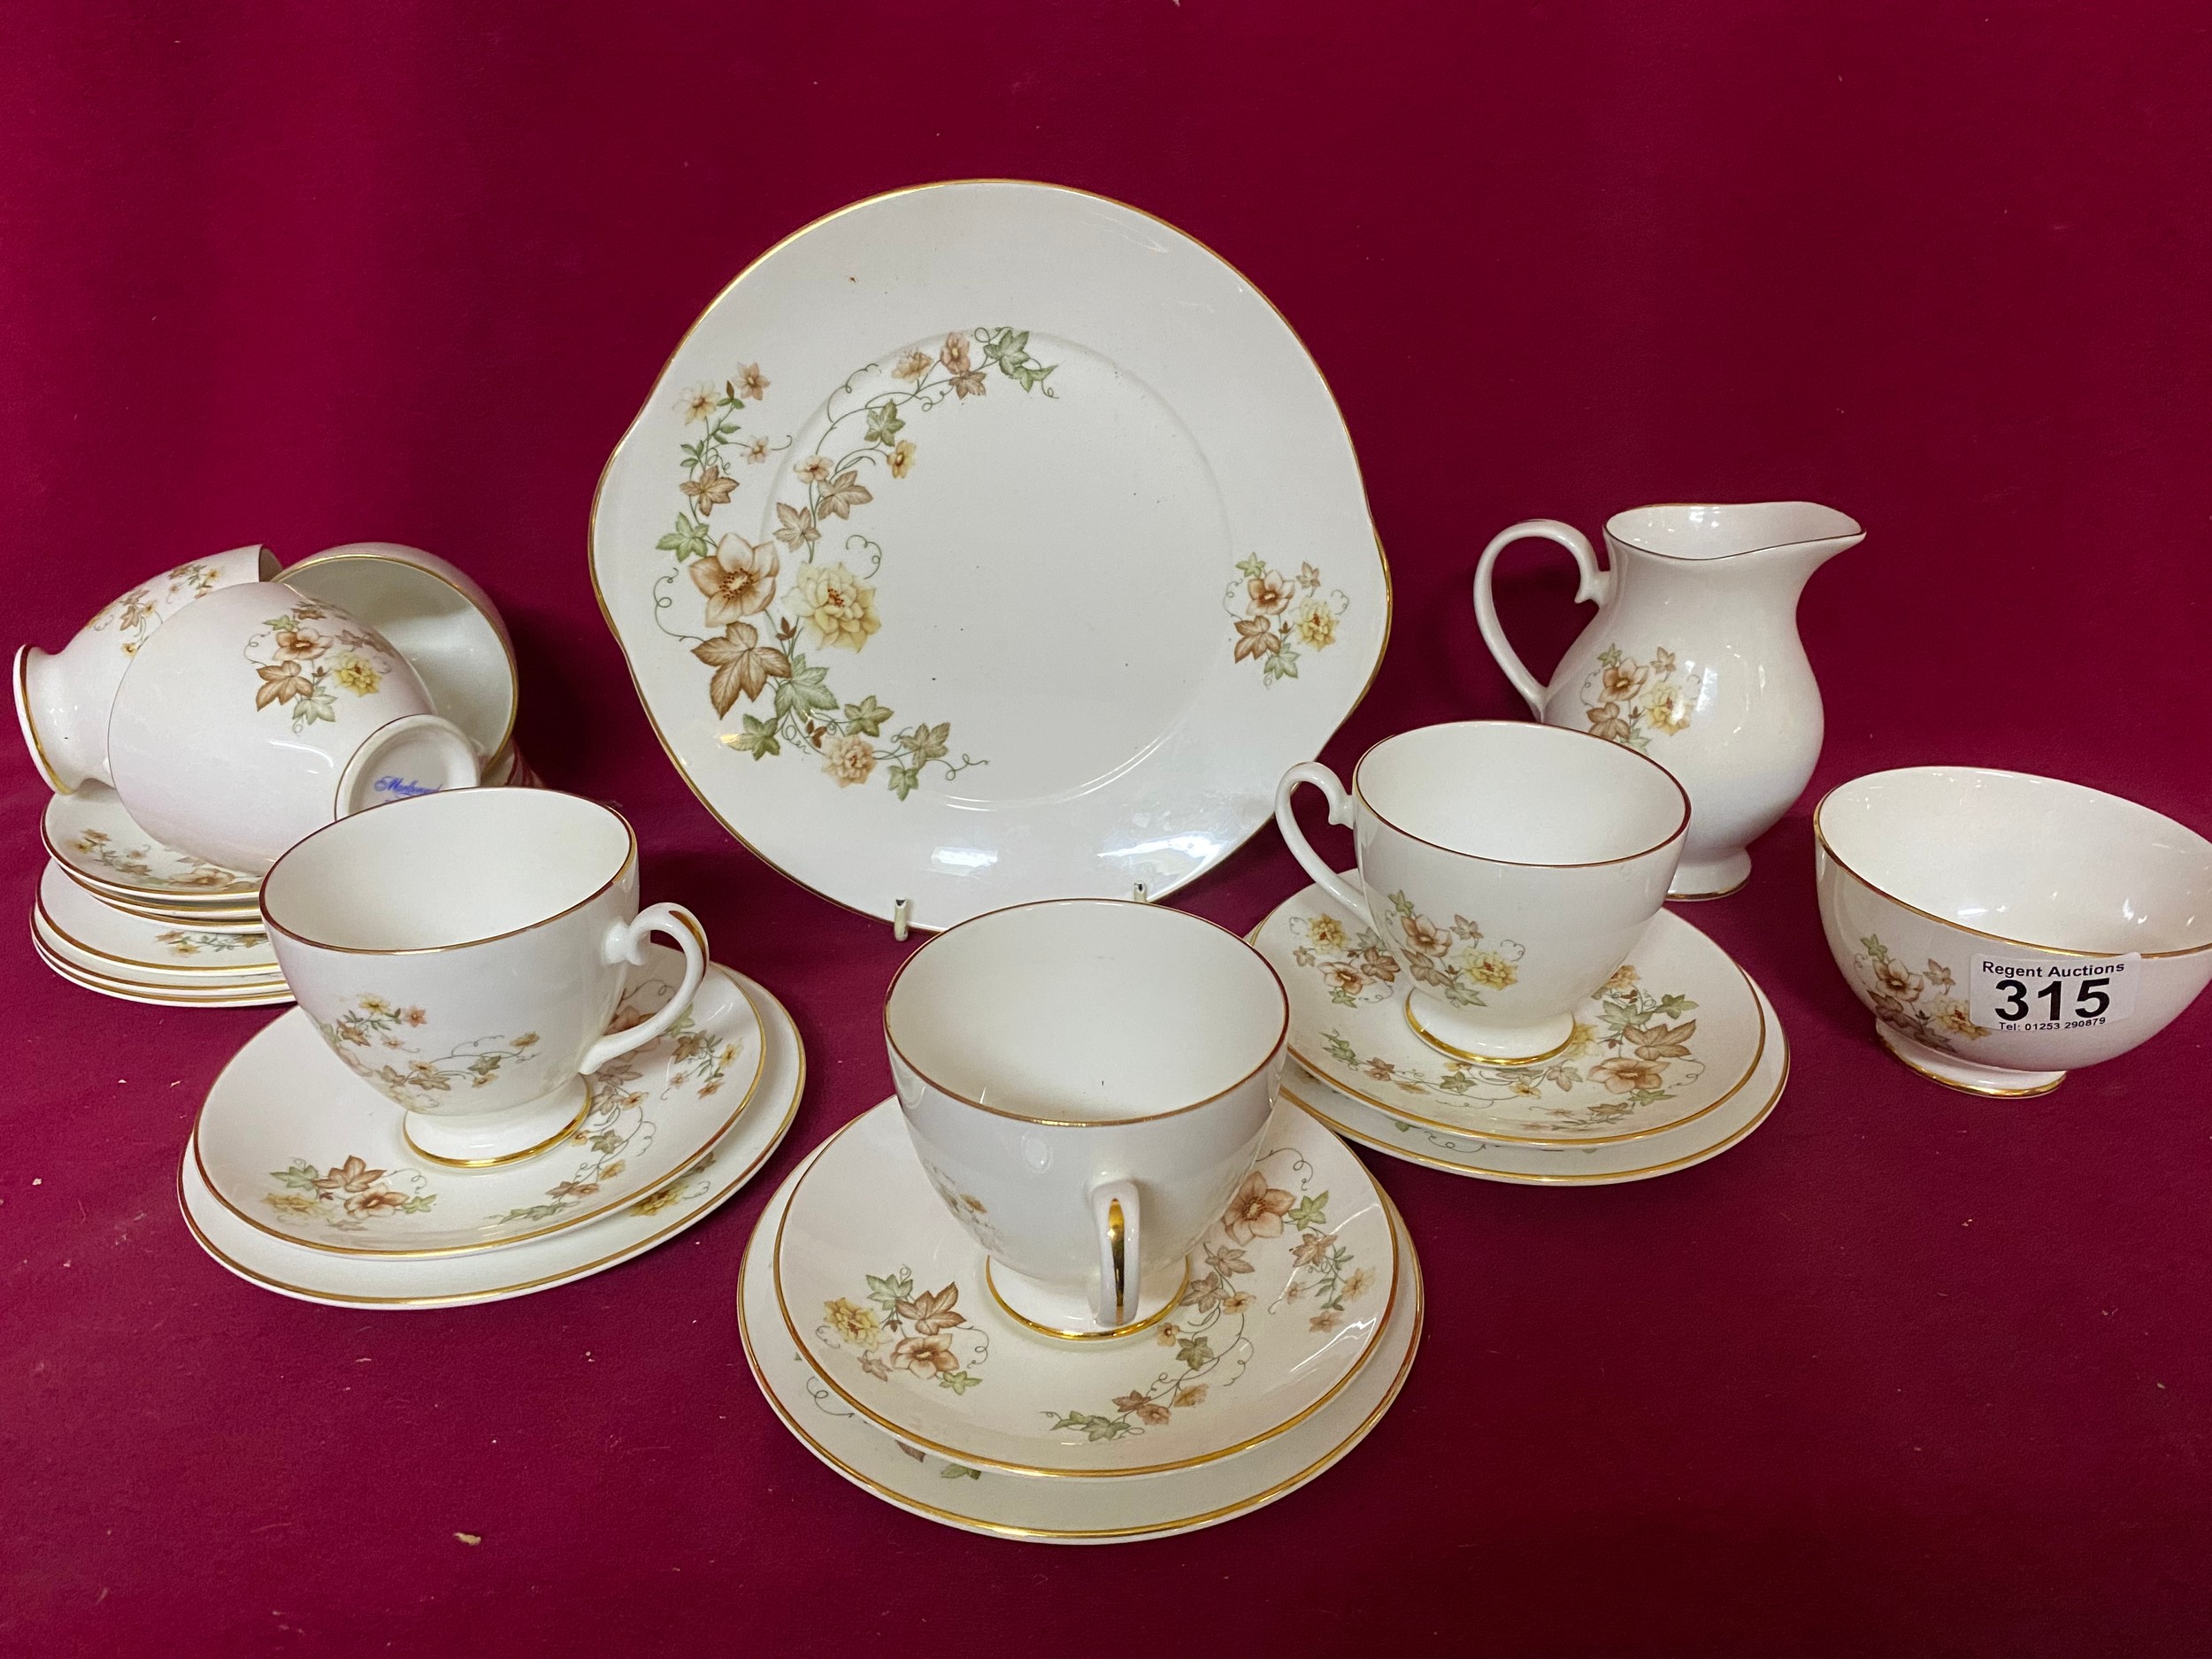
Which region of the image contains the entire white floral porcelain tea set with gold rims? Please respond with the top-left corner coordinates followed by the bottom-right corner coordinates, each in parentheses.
top-left (16, 181), bottom-right (2212, 1542)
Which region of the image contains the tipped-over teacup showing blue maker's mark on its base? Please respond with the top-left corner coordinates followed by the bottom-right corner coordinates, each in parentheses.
top-left (109, 582), bottom-right (478, 874)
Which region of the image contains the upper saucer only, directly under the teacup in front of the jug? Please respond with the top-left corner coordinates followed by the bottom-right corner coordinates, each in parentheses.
top-left (1252, 887), bottom-right (1768, 1148)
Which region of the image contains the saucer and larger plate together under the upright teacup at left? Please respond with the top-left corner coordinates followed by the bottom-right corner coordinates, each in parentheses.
top-left (177, 947), bottom-right (805, 1308)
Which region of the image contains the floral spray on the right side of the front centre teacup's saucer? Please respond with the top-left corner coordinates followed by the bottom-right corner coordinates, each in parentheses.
top-left (1053, 1148), bottom-right (1376, 1440)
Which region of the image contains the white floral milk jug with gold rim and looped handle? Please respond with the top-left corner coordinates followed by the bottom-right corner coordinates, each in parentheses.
top-left (1476, 503), bottom-right (1867, 898)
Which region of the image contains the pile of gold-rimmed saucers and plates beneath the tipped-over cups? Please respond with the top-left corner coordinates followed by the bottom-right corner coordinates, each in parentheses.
top-left (31, 746), bottom-right (544, 1007)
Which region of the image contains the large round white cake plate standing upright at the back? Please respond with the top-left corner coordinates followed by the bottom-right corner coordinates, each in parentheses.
top-left (593, 181), bottom-right (1389, 929)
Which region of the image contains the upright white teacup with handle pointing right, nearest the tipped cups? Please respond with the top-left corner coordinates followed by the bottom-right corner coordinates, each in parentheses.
top-left (261, 790), bottom-right (706, 1166)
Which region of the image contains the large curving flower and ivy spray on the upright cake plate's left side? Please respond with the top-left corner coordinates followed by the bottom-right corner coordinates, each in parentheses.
top-left (653, 327), bottom-right (1057, 801)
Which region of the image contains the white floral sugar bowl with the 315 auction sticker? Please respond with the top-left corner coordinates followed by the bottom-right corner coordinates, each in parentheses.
top-left (1812, 765), bottom-right (2212, 1095)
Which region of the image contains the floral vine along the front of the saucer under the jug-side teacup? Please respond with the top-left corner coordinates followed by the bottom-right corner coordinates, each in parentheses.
top-left (1321, 963), bottom-right (1706, 1133)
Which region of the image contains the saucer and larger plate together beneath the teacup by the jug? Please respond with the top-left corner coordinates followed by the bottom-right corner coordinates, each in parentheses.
top-left (1252, 876), bottom-right (1790, 1186)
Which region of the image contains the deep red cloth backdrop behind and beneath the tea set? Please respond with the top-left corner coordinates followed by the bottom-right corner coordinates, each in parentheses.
top-left (0, 0), bottom-right (2212, 1655)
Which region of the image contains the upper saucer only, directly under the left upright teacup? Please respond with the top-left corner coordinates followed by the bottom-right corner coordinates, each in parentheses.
top-left (193, 945), bottom-right (764, 1256)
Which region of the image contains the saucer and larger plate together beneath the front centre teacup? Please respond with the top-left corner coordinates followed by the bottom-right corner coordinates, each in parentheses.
top-left (737, 1100), bottom-right (1423, 1544)
